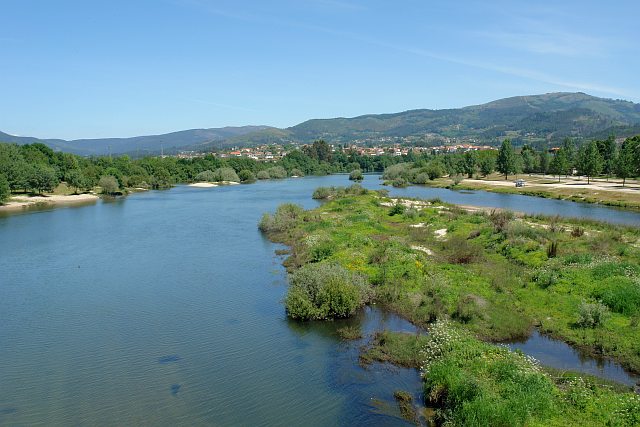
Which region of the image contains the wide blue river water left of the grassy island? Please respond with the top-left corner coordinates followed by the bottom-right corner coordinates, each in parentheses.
top-left (0, 175), bottom-right (640, 426)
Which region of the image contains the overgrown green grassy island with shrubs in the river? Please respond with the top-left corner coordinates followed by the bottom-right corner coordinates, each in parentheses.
top-left (260, 185), bottom-right (640, 425)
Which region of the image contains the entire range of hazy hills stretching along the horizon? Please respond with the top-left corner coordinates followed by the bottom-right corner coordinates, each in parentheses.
top-left (0, 92), bottom-right (640, 155)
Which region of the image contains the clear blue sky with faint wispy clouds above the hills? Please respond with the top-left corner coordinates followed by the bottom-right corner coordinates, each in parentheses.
top-left (0, 0), bottom-right (640, 139)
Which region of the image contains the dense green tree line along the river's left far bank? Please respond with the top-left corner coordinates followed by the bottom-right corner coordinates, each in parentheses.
top-left (0, 140), bottom-right (410, 203)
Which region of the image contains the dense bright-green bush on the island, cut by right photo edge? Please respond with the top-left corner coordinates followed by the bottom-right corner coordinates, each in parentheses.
top-left (593, 276), bottom-right (640, 316)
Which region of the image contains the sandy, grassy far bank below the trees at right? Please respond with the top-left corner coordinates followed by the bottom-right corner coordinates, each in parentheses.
top-left (416, 175), bottom-right (640, 211)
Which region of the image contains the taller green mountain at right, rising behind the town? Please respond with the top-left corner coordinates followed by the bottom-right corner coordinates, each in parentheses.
top-left (288, 92), bottom-right (640, 142)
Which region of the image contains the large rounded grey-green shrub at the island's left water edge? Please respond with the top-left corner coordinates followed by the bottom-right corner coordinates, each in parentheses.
top-left (285, 263), bottom-right (370, 320)
